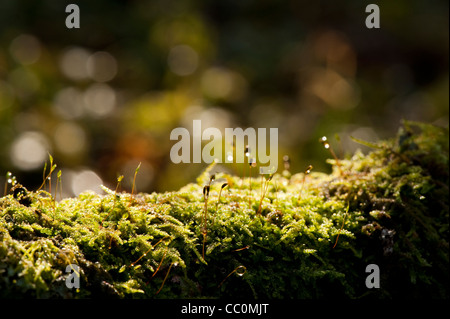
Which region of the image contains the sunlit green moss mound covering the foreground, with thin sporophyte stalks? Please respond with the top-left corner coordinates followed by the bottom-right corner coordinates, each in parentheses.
top-left (0, 121), bottom-right (449, 298)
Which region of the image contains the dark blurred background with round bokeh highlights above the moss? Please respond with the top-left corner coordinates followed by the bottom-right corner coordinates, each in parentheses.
top-left (0, 0), bottom-right (449, 196)
